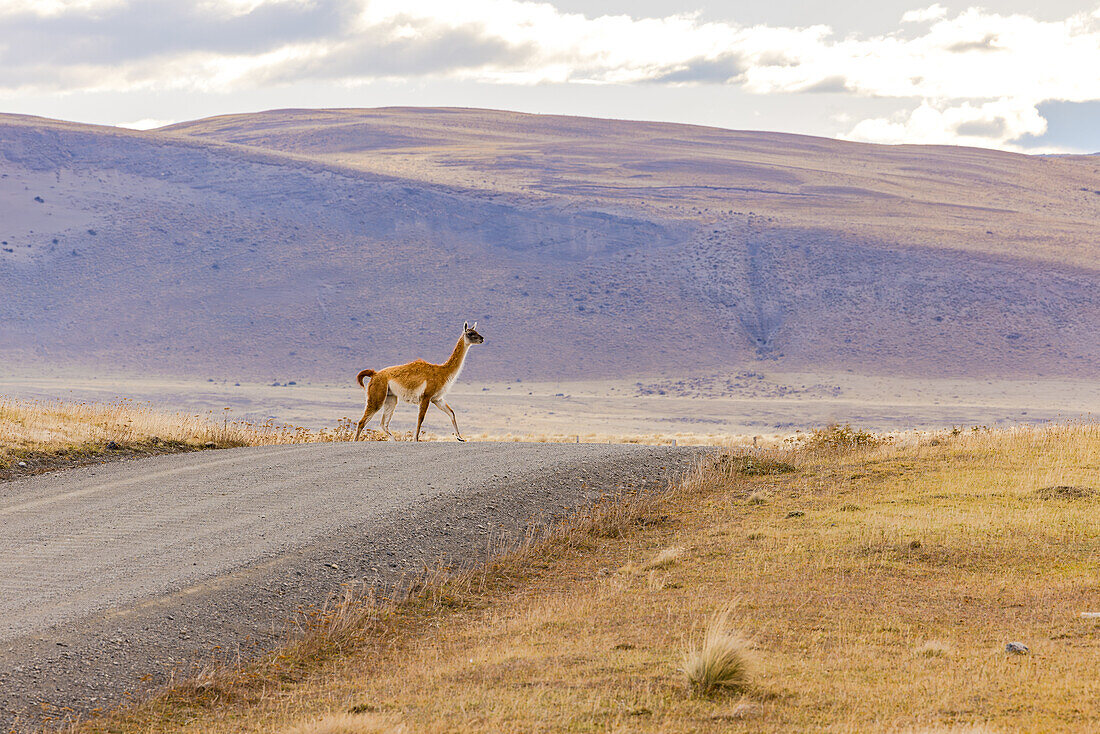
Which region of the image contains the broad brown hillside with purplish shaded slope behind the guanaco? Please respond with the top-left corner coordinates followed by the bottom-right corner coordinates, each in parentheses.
top-left (0, 108), bottom-right (1100, 380)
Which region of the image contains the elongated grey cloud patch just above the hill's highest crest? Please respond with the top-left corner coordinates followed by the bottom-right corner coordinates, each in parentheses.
top-left (253, 18), bottom-right (535, 83)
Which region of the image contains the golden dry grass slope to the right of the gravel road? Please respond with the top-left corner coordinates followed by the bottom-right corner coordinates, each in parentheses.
top-left (62, 424), bottom-right (1100, 733)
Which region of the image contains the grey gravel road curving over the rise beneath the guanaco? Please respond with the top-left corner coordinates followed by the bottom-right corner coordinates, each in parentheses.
top-left (0, 442), bottom-right (700, 730)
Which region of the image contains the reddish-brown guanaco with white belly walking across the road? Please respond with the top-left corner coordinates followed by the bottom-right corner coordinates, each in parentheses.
top-left (355, 321), bottom-right (485, 441)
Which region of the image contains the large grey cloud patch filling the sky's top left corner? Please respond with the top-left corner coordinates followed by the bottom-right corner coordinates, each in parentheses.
top-left (0, 0), bottom-right (359, 68)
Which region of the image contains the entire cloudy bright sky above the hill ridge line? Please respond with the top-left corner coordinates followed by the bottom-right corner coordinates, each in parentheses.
top-left (0, 0), bottom-right (1100, 153)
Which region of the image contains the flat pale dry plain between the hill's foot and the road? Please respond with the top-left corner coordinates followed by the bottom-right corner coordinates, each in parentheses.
top-left (0, 369), bottom-right (1100, 446)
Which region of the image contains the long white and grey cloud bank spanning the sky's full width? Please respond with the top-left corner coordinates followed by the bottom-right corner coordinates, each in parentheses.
top-left (0, 0), bottom-right (1100, 147)
